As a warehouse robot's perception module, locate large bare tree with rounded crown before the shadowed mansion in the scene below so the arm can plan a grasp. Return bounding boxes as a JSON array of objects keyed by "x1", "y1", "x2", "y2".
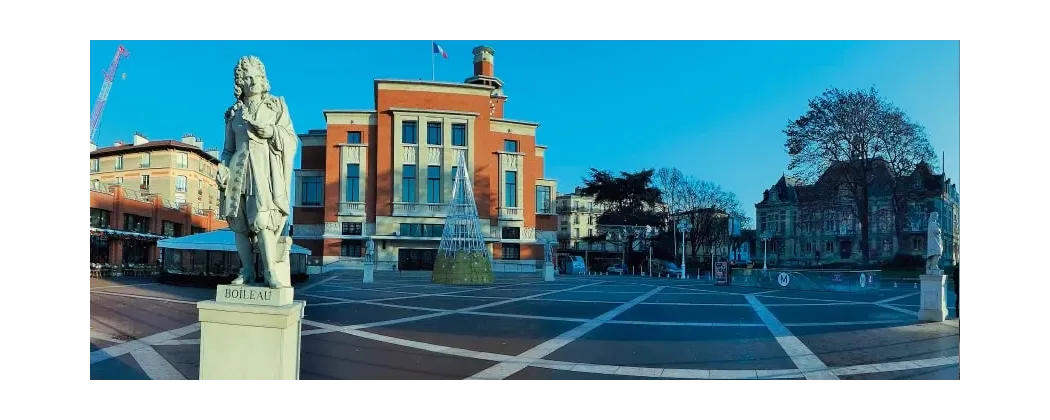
[{"x1": 784, "y1": 88, "x2": 928, "y2": 265}]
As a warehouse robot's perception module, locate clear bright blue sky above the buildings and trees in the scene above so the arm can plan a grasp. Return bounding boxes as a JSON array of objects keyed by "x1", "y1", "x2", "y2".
[{"x1": 87, "y1": 40, "x2": 962, "y2": 214}]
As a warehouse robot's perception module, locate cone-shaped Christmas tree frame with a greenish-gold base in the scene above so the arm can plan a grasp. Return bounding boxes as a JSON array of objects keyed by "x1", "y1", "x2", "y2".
[{"x1": 432, "y1": 152, "x2": 494, "y2": 285}]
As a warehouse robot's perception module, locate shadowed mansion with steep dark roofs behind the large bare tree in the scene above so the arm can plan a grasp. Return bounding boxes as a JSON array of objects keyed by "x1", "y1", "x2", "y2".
[{"x1": 755, "y1": 163, "x2": 959, "y2": 267}]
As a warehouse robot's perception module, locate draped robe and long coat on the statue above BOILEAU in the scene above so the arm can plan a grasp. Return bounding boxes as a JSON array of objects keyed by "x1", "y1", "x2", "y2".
[{"x1": 219, "y1": 95, "x2": 298, "y2": 233}]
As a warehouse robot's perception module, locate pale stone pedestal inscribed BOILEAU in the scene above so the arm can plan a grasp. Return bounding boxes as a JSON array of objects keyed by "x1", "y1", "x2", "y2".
[{"x1": 197, "y1": 285, "x2": 306, "y2": 382}]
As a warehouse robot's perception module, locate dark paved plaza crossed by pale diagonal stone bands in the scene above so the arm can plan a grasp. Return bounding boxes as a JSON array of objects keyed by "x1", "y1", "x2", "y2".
[{"x1": 88, "y1": 272, "x2": 959, "y2": 383}]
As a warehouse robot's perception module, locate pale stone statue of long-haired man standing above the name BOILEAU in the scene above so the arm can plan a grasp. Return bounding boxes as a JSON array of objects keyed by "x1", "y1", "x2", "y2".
[{"x1": 215, "y1": 57, "x2": 298, "y2": 289}]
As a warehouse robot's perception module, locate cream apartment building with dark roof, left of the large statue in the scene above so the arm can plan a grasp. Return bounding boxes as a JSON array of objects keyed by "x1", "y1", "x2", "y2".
[{"x1": 87, "y1": 133, "x2": 218, "y2": 209}]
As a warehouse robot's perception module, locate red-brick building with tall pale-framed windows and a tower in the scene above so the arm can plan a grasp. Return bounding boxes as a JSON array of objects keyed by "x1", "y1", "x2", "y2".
[{"x1": 292, "y1": 46, "x2": 558, "y2": 270}]
